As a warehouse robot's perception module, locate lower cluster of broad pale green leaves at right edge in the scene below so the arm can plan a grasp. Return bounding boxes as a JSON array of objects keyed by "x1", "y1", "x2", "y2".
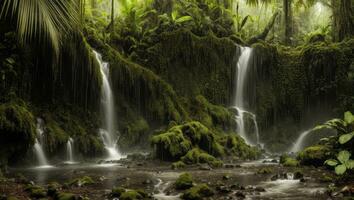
[{"x1": 325, "y1": 151, "x2": 354, "y2": 175}]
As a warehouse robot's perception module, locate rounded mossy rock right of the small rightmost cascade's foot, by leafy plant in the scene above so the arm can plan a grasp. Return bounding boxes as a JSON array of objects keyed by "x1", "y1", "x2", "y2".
[{"x1": 297, "y1": 145, "x2": 331, "y2": 167}]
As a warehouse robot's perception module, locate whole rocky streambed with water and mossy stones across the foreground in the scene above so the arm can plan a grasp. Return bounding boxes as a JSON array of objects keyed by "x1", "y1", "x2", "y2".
[{"x1": 0, "y1": 159, "x2": 350, "y2": 200}]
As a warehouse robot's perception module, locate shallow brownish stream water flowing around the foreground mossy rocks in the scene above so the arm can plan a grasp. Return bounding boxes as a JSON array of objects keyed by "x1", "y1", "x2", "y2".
[{"x1": 10, "y1": 159, "x2": 328, "y2": 200}]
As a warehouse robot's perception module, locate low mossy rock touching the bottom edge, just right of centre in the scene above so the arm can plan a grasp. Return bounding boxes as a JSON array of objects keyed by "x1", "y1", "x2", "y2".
[{"x1": 182, "y1": 184, "x2": 214, "y2": 200}]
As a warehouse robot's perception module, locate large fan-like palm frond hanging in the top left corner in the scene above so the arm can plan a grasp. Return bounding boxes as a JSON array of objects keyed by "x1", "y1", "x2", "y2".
[{"x1": 0, "y1": 0, "x2": 79, "y2": 54}]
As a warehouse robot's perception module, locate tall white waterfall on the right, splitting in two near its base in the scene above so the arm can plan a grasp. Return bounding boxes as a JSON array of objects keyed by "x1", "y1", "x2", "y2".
[{"x1": 233, "y1": 47, "x2": 259, "y2": 144}]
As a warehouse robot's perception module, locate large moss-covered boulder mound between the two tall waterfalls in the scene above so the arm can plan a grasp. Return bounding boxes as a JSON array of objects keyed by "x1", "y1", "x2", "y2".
[{"x1": 151, "y1": 121, "x2": 260, "y2": 164}]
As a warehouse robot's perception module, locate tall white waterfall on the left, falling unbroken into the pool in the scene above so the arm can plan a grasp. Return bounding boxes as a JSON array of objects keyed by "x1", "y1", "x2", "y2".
[{"x1": 93, "y1": 51, "x2": 122, "y2": 160}]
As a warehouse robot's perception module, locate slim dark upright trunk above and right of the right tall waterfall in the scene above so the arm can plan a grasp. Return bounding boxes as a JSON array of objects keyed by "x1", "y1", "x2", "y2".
[{"x1": 283, "y1": 0, "x2": 293, "y2": 45}]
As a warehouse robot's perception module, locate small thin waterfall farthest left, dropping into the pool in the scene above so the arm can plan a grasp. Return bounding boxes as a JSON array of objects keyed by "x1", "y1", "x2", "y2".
[{"x1": 33, "y1": 118, "x2": 49, "y2": 167}]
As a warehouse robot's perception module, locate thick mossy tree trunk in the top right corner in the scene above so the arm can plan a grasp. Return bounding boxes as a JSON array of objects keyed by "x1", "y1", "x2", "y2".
[{"x1": 331, "y1": 0, "x2": 354, "y2": 41}]
